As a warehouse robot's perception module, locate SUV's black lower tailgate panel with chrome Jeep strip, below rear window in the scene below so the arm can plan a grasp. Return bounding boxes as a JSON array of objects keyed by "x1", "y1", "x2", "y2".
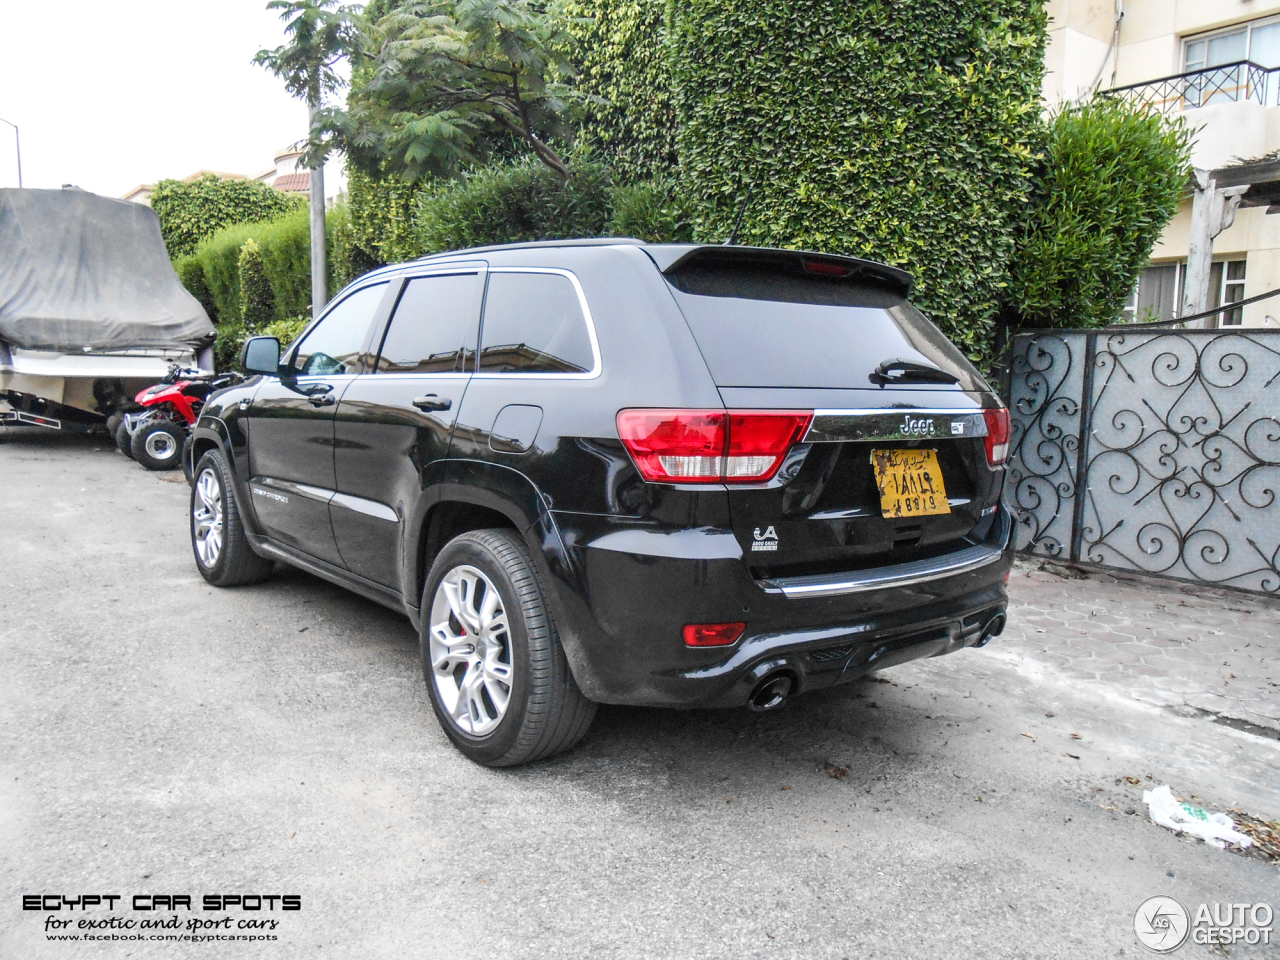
[{"x1": 721, "y1": 388, "x2": 1004, "y2": 577}]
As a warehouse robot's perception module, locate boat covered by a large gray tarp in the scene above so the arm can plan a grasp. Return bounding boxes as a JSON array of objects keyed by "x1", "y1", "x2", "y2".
[{"x1": 0, "y1": 187, "x2": 215, "y2": 426}]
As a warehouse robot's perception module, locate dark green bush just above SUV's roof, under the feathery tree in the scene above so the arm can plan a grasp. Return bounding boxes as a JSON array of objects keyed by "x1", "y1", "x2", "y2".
[{"x1": 416, "y1": 154, "x2": 611, "y2": 253}]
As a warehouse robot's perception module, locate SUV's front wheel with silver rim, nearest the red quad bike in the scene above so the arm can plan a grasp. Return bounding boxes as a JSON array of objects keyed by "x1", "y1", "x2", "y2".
[{"x1": 187, "y1": 449, "x2": 275, "y2": 586}]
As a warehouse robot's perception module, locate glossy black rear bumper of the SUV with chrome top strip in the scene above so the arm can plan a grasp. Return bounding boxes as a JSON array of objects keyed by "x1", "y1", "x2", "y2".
[{"x1": 545, "y1": 507, "x2": 1012, "y2": 707}]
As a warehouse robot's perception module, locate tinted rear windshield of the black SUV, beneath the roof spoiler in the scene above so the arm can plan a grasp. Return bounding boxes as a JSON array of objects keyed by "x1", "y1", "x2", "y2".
[{"x1": 667, "y1": 261, "x2": 984, "y2": 390}]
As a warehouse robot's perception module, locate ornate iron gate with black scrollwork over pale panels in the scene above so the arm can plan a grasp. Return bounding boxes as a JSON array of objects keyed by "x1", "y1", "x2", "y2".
[{"x1": 1006, "y1": 329, "x2": 1280, "y2": 594}]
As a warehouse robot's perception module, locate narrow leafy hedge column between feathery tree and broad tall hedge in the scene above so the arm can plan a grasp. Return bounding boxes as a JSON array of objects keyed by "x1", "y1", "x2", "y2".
[{"x1": 563, "y1": 0, "x2": 676, "y2": 183}]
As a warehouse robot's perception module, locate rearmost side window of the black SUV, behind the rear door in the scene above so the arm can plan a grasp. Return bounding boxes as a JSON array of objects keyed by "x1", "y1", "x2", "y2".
[{"x1": 480, "y1": 273, "x2": 595, "y2": 374}]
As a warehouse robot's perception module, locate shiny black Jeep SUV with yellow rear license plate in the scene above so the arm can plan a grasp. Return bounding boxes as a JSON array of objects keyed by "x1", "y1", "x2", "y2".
[{"x1": 187, "y1": 241, "x2": 1012, "y2": 765}]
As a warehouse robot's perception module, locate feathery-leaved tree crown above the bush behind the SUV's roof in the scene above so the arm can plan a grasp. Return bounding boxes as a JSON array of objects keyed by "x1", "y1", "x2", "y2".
[{"x1": 328, "y1": 0, "x2": 581, "y2": 180}]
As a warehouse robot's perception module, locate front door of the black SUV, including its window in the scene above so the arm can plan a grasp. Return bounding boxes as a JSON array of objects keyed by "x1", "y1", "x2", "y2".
[{"x1": 244, "y1": 282, "x2": 389, "y2": 564}]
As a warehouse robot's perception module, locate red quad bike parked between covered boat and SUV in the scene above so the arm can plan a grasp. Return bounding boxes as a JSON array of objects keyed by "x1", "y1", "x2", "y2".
[{"x1": 115, "y1": 365, "x2": 244, "y2": 480}]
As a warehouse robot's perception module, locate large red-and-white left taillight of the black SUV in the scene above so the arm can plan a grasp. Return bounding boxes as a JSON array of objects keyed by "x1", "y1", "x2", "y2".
[{"x1": 618, "y1": 410, "x2": 813, "y2": 484}]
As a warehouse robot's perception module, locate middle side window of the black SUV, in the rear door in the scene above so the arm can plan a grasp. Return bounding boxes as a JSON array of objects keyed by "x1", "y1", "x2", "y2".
[{"x1": 378, "y1": 274, "x2": 480, "y2": 374}]
